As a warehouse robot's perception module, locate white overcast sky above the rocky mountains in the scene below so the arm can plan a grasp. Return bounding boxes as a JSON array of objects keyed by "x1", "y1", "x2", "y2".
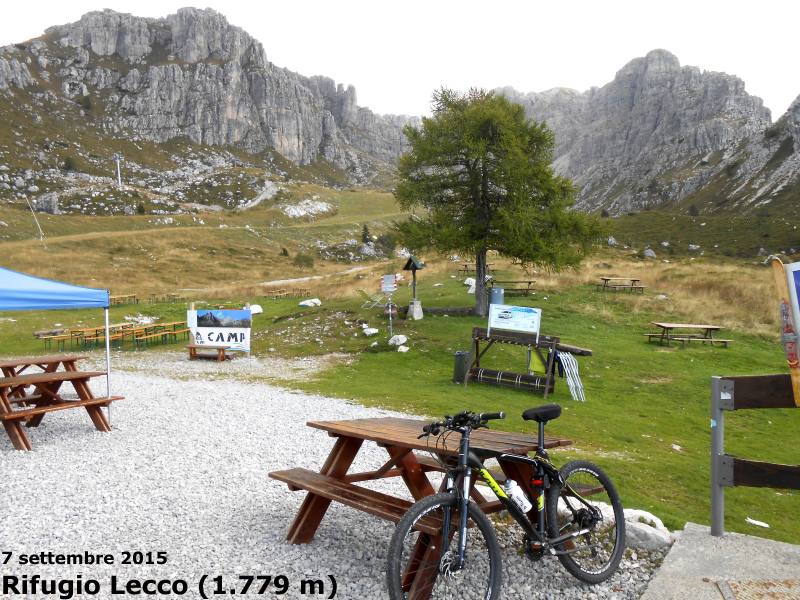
[{"x1": 0, "y1": 0, "x2": 800, "y2": 120}]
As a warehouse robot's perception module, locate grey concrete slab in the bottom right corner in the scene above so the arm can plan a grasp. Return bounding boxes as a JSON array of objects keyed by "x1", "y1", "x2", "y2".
[{"x1": 641, "y1": 523, "x2": 800, "y2": 600}]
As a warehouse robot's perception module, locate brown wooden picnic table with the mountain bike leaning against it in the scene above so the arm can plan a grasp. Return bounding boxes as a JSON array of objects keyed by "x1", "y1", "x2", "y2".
[{"x1": 269, "y1": 417, "x2": 572, "y2": 544}]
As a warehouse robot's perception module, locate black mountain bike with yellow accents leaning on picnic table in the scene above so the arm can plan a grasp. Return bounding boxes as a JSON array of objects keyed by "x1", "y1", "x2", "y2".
[{"x1": 387, "y1": 404, "x2": 625, "y2": 600}]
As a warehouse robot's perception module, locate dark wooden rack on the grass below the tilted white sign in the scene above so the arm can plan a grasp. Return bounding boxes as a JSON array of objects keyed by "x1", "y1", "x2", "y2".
[{"x1": 464, "y1": 327, "x2": 559, "y2": 398}]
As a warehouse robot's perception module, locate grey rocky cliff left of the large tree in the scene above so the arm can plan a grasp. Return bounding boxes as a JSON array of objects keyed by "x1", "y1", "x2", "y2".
[{"x1": 0, "y1": 8, "x2": 418, "y2": 180}]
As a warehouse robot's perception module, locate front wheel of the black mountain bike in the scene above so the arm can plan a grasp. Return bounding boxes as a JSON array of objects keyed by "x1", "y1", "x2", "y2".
[{"x1": 387, "y1": 494, "x2": 501, "y2": 600}]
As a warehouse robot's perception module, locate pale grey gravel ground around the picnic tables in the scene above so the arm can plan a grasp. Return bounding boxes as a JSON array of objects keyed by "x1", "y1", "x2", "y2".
[{"x1": 0, "y1": 353, "x2": 663, "y2": 600}]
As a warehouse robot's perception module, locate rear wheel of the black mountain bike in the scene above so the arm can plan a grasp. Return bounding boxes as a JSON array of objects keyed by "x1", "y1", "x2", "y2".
[{"x1": 547, "y1": 460, "x2": 625, "y2": 583}]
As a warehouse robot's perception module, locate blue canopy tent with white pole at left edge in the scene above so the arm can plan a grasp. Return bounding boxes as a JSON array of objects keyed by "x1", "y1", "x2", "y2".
[{"x1": 0, "y1": 267, "x2": 111, "y2": 412}]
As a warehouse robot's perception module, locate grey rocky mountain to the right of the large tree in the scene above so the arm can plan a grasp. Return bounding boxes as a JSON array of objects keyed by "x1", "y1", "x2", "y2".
[{"x1": 497, "y1": 50, "x2": 800, "y2": 215}]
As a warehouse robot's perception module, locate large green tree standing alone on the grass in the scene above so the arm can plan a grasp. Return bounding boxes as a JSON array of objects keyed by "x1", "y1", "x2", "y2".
[{"x1": 394, "y1": 88, "x2": 602, "y2": 316}]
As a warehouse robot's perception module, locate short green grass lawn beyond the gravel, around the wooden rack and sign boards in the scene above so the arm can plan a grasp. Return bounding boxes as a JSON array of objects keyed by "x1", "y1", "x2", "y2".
[{"x1": 2, "y1": 252, "x2": 800, "y2": 542}]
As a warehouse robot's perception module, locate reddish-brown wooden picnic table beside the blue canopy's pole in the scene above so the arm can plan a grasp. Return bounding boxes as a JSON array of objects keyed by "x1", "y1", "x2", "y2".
[{"x1": 0, "y1": 362, "x2": 123, "y2": 450}]
